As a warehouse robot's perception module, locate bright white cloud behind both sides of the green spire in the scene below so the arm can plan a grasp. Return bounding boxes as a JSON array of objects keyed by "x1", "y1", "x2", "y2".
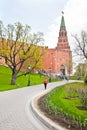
[{"x1": 45, "y1": 0, "x2": 87, "y2": 48}]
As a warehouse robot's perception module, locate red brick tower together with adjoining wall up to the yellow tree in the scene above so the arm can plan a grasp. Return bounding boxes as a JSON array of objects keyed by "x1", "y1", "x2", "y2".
[{"x1": 43, "y1": 12, "x2": 72, "y2": 75}]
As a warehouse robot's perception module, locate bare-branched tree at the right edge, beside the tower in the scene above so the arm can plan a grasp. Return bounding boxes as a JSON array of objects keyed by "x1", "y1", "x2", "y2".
[{"x1": 73, "y1": 31, "x2": 87, "y2": 60}]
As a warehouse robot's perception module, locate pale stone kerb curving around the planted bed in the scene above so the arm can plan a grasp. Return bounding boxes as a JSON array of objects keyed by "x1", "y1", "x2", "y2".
[{"x1": 30, "y1": 89, "x2": 67, "y2": 130}]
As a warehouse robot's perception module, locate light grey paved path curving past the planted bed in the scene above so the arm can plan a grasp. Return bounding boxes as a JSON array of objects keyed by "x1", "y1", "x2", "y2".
[{"x1": 0, "y1": 81, "x2": 72, "y2": 130}]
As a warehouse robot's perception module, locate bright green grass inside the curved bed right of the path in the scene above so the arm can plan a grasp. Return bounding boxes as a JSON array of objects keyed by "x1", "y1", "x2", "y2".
[{"x1": 42, "y1": 83, "x2": 87, "y2": 129}]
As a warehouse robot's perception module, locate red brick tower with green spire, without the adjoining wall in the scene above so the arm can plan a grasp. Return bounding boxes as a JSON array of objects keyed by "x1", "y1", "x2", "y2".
[{"x1": 57, "y1": 12, "x2": 72, "y2": 75}]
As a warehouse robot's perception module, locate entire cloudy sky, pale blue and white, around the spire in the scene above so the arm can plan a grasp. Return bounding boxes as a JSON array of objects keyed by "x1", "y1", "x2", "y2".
[{"x1": 0, "y1": 0, "x2": 87, "y2": 48}]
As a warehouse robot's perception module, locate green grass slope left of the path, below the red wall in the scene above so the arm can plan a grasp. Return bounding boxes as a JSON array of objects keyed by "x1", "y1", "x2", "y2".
[{"x1": 0, "y1": 66, "x2": 44, "y2": 91}]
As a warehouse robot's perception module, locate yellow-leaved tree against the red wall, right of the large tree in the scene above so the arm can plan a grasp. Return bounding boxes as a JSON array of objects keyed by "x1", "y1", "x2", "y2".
[{"x1": 22, "y1": 45, "x2": 46, "y2": 71}]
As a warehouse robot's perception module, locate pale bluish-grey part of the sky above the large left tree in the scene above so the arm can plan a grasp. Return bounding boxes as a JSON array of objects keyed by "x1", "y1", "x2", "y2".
[{"x1": 0, "y1": 0, "x2": 67, "y2": 32}]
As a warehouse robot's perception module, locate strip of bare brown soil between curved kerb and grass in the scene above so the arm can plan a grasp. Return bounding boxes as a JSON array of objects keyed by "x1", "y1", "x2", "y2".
[{"x1": 38, "y1": 95, "x2": 87, "y2": 130}]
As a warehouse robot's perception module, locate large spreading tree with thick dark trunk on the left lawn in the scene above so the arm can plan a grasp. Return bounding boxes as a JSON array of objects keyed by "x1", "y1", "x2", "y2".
[{"x1": 0, "y1": 21, "x2": 43, "y2": 85}]
